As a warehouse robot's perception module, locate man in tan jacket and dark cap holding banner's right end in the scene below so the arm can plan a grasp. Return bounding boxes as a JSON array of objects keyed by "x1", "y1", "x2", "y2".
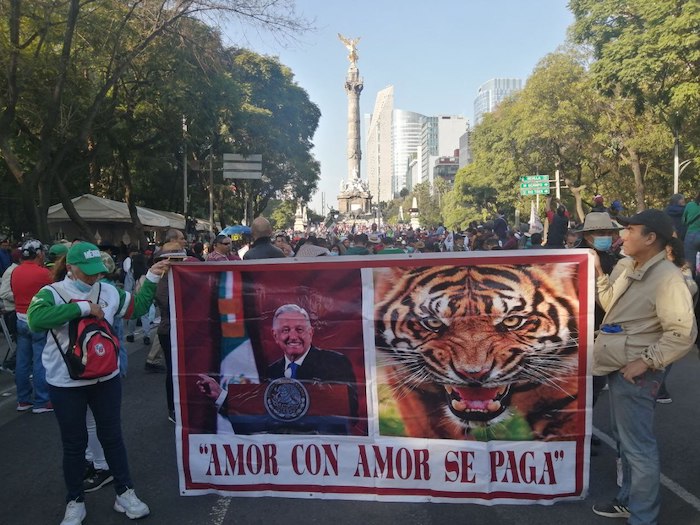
[{"x1": 593, "y1": 210, "x2": 697, "y2": 525}]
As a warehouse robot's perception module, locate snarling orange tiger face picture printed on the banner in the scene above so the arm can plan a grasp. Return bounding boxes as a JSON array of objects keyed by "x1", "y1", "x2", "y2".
[{"x1": 375, "y1": 264, "x2": 578, "y2": 439}]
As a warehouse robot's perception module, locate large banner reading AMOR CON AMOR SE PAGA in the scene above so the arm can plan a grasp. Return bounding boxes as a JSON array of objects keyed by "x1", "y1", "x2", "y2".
[{"x1": 170, "y1": 250, "x2": 593, "y2": 504}]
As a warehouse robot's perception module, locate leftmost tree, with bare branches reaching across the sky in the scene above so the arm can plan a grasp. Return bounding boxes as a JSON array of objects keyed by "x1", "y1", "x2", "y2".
[{"x1": 0, "y1": 0, "x2": 307, "y2": 240}]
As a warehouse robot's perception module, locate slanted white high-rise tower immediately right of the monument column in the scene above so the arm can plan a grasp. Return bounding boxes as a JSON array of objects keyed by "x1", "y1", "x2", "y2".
[{"x1": 365, "y1": 86, "x2": 395, "y2": 203}]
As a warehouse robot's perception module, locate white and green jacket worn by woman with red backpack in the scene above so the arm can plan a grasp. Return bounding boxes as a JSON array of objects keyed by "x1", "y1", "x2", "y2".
[{"x1": 27, "y1": 271, "x2": 160, "y2": 387}]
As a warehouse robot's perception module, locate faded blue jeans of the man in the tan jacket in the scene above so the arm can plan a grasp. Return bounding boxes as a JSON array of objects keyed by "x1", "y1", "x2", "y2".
[{"x1": 608, "y1": 370, "x2": 664, "y2": 525}]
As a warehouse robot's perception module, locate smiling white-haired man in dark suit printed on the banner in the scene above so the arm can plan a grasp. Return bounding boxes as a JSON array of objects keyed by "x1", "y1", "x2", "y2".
[{"x1": 197, "y1": 304, "x2": 358, "y2": 433}]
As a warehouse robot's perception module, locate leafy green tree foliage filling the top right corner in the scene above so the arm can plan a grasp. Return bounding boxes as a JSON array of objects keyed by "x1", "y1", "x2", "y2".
[{"x1": 569, "y1": 0, "x2": 700, "y2": 186}]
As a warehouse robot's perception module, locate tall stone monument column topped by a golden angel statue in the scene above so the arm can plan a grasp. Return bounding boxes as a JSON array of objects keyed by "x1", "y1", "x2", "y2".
[{"x1": 338, "y1": 33, "x2": 372, "y2": 218}]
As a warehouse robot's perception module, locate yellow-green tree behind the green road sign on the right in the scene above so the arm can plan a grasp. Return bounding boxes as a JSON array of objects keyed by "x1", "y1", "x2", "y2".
[{"x1": 443, "y1": 49, "x2": 670, "y2": 223}]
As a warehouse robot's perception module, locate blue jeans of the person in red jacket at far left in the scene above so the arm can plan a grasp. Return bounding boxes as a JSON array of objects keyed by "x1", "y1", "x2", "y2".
[{"x1": 15, "y1": 319, "x2": 49, "y2": 408}]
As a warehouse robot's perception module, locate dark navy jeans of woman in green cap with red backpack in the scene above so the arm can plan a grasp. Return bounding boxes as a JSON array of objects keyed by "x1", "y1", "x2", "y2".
[{"x1": 49, "y1": 376, "x2": 133, "y2": 502}]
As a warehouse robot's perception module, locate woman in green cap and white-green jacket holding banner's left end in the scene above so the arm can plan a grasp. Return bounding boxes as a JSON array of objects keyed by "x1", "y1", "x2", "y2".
[{"x1": 27, "y1": 242, "x2": 170, "y2": 525}]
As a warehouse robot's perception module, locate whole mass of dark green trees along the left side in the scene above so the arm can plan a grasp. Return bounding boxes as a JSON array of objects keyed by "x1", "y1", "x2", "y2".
[{"x1": 0, "y1": 0, "x2": 320, "y2": 240}]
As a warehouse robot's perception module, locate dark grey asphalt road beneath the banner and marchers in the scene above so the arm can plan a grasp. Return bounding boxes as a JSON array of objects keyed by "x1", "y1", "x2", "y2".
[{"x1": 0, "y1": 341, "x2": 700, "y2": 525}]
